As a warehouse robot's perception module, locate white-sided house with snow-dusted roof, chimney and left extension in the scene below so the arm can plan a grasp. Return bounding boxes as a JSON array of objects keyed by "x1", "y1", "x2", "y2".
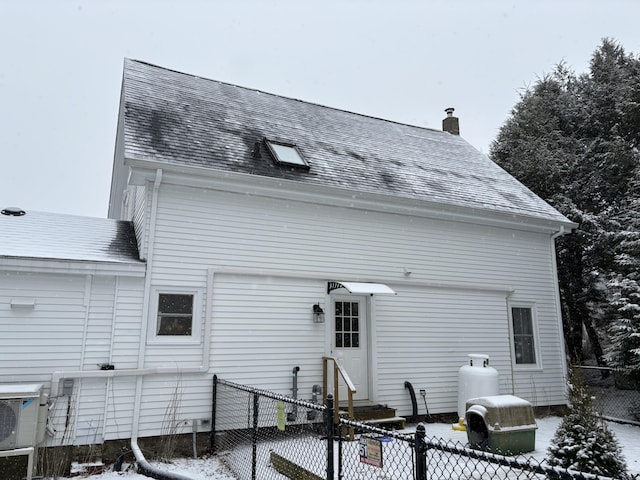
[{"x1": 0, "y1": 60, "x2": 575, "y2": 454}]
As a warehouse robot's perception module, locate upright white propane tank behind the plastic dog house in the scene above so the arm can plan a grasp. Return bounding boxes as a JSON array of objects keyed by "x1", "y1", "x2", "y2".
[{"x1": 458, "y1": 353, "x2": 499, "y2": 419}]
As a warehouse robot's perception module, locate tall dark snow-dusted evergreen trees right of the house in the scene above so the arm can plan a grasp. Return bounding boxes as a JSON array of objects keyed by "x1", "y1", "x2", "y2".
[{"x1": 491, "y1": 40, "x2": 640, "y2": 365}]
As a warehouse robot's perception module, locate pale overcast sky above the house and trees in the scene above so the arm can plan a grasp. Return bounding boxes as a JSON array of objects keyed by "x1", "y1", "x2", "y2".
[{"x1": 0, "y1": 0, "x2": 640, "y2": 217}]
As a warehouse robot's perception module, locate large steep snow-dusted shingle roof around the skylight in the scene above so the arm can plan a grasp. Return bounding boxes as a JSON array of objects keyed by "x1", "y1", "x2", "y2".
[{"x1": 123, "y1": 60, "x2": 568, "y2": 223}]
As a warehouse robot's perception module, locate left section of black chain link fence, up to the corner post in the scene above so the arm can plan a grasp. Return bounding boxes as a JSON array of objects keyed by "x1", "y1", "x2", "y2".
[{"x1": 211, "y1": 377, "x2": 329, "y2": 480}]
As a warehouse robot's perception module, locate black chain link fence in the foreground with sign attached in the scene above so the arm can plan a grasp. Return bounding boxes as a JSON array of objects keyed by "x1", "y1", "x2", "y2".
[{"x1": 211, "y1": 376, "x2": 632, "y2": 480}]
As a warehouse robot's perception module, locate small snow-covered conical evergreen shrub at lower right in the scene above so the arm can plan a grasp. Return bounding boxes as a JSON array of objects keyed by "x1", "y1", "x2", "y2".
[{"x1": 547, "y1": 371, "x2": 629, "y2": 479}]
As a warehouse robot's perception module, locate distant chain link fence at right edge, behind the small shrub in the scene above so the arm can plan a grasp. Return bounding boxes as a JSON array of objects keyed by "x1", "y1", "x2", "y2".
[{"x1": 577, "y1": 365, "x2": 640, "y2": 425}]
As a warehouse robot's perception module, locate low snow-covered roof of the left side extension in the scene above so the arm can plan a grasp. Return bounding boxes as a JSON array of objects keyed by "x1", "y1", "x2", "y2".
[{"x1": 0, "y1": 211, "x2": 140, "y2": 263}]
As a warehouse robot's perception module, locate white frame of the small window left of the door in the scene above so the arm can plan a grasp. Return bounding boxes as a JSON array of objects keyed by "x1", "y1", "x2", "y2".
[{"x1": 147, "y1": 287, "x2": 204, "y2": 345}]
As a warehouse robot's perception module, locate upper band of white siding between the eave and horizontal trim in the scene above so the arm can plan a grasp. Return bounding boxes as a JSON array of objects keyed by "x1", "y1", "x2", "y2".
[{"x1": 152, "y1": 186, "x2": 550, "y2": 289}]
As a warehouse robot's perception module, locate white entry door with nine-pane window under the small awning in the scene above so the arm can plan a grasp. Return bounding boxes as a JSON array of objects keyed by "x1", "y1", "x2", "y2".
[{"x1": 331, "y1": 296, "x2": 369, "y2": 400}]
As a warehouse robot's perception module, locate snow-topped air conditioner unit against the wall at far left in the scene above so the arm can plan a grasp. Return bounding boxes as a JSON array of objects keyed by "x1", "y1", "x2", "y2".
[{"x1": 0, "y1": 384, "x2": 46, "y2": 451}]
